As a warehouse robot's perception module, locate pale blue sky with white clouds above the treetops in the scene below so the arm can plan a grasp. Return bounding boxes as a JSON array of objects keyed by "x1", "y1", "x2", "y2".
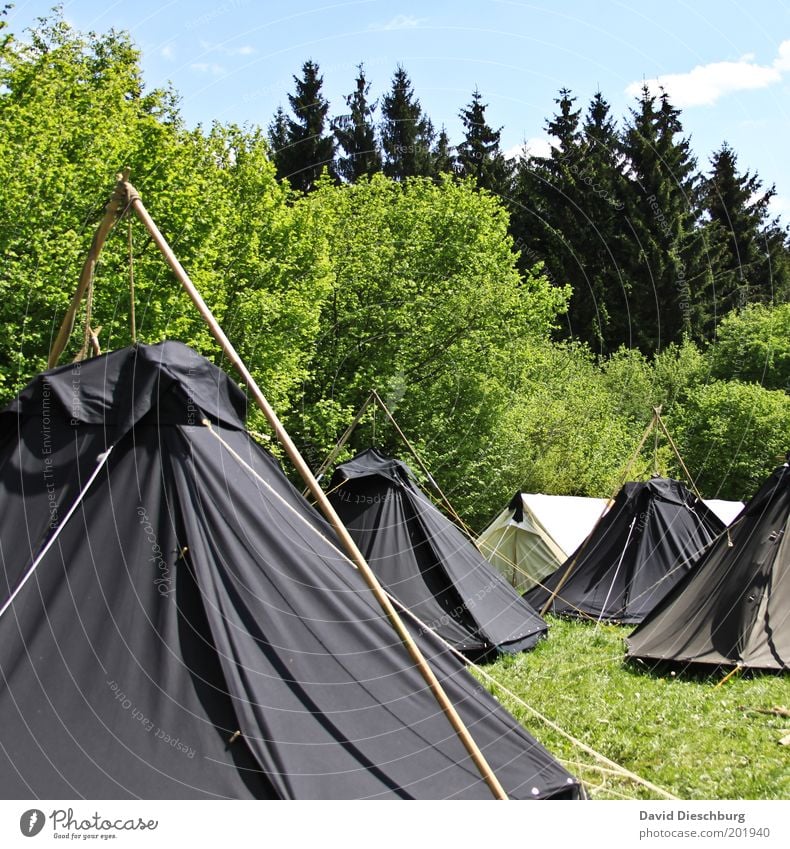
[{"x1": 10, "y1": 0, "x2": 790, "y2": 221}]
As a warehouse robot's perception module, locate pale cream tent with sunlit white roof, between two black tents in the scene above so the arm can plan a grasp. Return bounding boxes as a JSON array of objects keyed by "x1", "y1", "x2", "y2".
[{"x1": 477, "y1": 492, "x2": 607, "y2": 592}]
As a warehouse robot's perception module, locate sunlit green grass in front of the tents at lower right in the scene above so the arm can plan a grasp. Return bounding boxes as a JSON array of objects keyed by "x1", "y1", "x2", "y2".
[{"x1": 476, "y1": 617, "x2": 790, "y2": 799}]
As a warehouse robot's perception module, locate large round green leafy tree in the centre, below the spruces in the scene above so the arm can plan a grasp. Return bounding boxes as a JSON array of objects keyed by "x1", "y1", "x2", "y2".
[{"x1": 298, "y1": 175, "x2": 565, "y2": 510}]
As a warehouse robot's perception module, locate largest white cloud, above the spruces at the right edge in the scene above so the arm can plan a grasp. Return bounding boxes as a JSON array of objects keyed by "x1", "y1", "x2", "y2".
[{"x1": 625, "y1": 40, "x2": 790, "y2": 109}]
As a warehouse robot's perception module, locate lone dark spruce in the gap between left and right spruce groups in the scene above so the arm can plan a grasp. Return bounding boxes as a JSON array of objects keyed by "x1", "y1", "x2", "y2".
[{"x1": 457, "y1": 89, "x2": 510, "y2": 196}]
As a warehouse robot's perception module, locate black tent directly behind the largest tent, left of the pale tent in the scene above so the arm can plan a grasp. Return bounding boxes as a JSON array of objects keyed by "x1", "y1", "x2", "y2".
[{"x1": 329, "y1": 448, "x2": 548, "y2": 657}]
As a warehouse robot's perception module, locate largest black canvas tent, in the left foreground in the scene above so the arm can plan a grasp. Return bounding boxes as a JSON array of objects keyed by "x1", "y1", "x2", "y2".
[{"x1": 0, "y1": 342, "x2": 579, "y2": 799}]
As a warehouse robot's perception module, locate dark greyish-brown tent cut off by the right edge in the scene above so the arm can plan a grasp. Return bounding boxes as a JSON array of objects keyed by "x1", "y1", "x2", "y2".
[{"x1": 628, "y1": 464, "x2": 790, "y2": 670}]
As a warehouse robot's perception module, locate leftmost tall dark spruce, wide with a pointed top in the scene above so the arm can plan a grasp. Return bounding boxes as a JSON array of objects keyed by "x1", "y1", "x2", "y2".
[{"x1": 269, "y1": 59, "x2": 335, "y2": 192}]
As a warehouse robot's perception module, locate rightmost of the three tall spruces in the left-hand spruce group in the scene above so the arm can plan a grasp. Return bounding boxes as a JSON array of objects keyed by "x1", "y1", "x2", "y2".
[{"x1": 380, "y1": 66, "x2": 435, "y2": 180}]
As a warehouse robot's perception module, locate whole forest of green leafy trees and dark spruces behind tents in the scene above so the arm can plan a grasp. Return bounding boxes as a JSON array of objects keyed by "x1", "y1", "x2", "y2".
[{"x1": 0, "y1": 13, "x2": 790, "y2": 529}]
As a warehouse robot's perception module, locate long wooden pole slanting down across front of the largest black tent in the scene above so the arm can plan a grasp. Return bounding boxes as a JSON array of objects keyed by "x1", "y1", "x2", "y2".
[{"x1": 126, "y1": 183, "x2": 507, "y2": 799}]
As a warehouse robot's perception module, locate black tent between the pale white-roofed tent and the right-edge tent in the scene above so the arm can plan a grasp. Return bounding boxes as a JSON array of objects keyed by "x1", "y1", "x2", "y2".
[{"x1": 525, "y1": 477, "x2": 724, "y2": 624}]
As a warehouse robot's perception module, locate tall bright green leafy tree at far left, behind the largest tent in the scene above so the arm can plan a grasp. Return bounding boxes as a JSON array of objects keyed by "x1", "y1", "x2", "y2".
[{"x1": 0, "y1": 15, "x2": 329, "y2": 409}]
